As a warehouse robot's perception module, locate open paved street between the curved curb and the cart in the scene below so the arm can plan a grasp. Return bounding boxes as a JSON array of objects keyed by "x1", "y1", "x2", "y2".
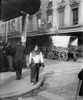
[{"x1": 0, "y1": 59, "x2": 82, "y2": 100}]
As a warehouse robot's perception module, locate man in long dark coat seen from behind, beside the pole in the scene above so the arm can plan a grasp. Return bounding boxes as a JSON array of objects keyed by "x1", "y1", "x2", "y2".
[{"x1": 13, "y1": 42, "x2": 25, "y2": 80}]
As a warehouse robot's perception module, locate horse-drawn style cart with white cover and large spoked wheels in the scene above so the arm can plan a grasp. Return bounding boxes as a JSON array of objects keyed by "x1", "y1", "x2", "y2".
[{"x1": 46, "y1": 36, "x2": 78, "y2": 61}]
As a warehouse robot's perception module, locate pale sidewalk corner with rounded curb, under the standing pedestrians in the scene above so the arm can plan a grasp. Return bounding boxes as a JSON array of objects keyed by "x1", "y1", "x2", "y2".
[{"x1": 0, "y1": 69, "x2": 43, "y2": 99}]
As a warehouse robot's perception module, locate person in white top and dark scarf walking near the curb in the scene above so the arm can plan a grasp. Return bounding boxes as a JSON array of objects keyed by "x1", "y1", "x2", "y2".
[{"x1": 29, "y1": 44, "x2": 44, "y2": 85}]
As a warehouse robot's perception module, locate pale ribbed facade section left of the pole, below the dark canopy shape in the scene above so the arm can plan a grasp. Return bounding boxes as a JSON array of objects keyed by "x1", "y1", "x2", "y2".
[{"x1": 0, "y1": 16, "x2": 22, "y2": 42}]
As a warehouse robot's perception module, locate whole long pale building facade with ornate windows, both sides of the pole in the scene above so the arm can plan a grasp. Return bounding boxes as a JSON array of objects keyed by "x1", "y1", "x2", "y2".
[{"x1": 0, "y1": 0, "x2": 83, "y2": 44}]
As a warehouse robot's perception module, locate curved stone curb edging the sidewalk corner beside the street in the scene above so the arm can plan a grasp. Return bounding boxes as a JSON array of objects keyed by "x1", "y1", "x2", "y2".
[{"x1": 0, "y1": 77, "x2": 44, "y2": 100}]
